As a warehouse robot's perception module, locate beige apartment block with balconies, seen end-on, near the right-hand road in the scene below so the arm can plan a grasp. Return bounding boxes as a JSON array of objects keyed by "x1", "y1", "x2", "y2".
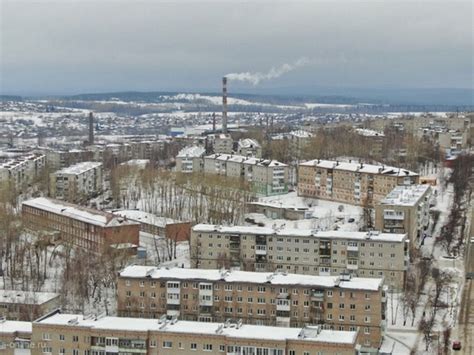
[{"x1": 375, "y1": 185, "x2": 431, "y2": 247}]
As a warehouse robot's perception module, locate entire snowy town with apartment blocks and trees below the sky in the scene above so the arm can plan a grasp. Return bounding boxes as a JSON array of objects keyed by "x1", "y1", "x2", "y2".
[{"x1": 0, "y1": 81, "x2": 474, "y2": 355}]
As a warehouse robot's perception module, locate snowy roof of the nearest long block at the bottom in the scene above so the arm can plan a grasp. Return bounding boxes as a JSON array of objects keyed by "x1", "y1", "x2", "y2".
[{"x1": 35, "y1": 313, "x2": 357, "y2": 344}]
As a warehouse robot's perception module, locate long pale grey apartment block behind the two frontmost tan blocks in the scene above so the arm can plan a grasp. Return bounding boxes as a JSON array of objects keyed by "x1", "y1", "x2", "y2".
[{"x1": 190, "y1": 224, "x2": 409, "y2": 288}]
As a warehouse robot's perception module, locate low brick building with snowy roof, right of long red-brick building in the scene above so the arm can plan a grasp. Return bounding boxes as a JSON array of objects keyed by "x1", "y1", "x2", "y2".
[{"x1": 112, "y1": 210, "x2": 191, "y2": 242}]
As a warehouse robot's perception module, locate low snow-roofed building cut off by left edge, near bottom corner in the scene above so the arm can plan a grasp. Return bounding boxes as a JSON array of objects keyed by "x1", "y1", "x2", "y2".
[{"x1": 0, "y1": 290, "x2": 59, "y2": 321}]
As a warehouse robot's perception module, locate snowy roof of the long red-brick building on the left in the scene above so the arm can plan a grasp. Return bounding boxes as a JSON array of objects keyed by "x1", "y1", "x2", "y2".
[{"x1": 23, "y1": 197, "x2": 138, "y2": 227}]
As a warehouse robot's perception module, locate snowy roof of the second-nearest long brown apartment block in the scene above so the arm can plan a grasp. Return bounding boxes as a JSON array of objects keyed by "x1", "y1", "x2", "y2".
[{"x1": 120, "y1": 265, "x2": 383, "y2": 291}]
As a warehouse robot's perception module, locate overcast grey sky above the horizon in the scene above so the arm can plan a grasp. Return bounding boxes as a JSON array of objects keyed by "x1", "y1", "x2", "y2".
[{"x1": 0, "y1": 0, "x2": 473, "y2": 94}]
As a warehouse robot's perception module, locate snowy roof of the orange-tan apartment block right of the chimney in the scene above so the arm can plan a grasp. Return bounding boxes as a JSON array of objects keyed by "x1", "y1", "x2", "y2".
[{"x1": 300, "y1": 159, "x2": 418, "y2": 176}]
